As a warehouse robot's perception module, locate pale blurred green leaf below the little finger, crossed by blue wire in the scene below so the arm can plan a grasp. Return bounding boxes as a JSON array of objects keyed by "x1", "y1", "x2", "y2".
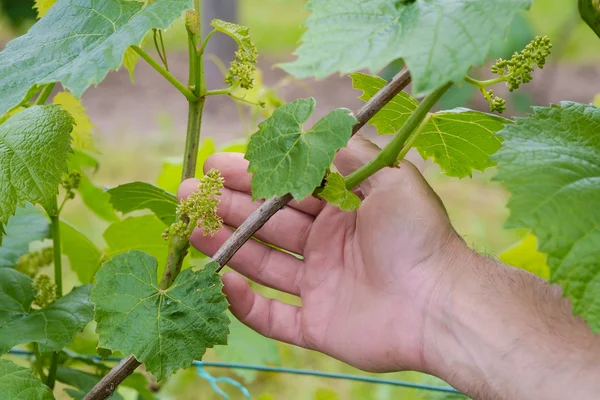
[{"x1": 215, "y1": 312, "x2": 281, "y2": 383}]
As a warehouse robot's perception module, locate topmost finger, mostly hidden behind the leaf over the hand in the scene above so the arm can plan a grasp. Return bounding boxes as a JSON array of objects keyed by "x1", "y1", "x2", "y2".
[{"x1": 204, "y1": 153, "x2": 326, "y2": 216}]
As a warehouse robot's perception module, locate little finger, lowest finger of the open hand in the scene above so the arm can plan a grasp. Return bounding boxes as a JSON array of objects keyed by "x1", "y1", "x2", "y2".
[{"x1": 223, "y1": 272, "x2": 307, "y2": 347}]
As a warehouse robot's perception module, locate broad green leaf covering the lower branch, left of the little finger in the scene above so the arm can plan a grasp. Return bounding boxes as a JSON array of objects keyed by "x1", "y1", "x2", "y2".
[{"x1": 92, "y1": 250, "x2": 229, "y2": 379}]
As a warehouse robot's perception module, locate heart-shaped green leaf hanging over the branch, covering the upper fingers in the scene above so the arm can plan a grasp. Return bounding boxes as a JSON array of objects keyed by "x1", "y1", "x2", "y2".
[{"x1": 246, "y1": 97, "x2": 356, "y2": 200}]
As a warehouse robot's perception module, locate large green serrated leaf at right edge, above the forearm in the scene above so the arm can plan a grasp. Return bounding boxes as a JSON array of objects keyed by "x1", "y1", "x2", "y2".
[{"x1": 495, "y1": 102, "x2": 600, "y2": 331}]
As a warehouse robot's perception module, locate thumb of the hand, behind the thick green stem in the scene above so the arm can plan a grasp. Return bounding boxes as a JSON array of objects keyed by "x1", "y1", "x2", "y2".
[{"x1": 334, "y1": 135, "x2": 420, "y2": 196}]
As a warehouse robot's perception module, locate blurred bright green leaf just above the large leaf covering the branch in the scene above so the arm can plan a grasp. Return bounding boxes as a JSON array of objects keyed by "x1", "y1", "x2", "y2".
[{"x1": 103, "y1": 214, "x2": 169, "y2": 272}]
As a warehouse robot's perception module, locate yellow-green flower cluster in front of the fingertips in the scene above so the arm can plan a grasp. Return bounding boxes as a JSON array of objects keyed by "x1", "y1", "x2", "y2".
[{"x1": 163, "y1": 169, "x2": 224, "y2": 240}]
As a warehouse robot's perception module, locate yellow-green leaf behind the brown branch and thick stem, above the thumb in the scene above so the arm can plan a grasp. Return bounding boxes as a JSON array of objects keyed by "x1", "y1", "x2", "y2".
[{"x1": 352, "y1": 73, "x2": 511, "y2": 178}]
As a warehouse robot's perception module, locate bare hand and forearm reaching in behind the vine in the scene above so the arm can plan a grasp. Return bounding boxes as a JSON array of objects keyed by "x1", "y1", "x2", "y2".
[{"x1": 179, "y1": 136, "x2": 600, "y2": 400}]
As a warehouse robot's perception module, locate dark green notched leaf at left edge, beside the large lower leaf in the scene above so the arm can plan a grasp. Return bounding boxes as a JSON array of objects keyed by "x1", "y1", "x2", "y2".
[{"x1": 0, "y1": 268, "x2": 93, "y2": 354}]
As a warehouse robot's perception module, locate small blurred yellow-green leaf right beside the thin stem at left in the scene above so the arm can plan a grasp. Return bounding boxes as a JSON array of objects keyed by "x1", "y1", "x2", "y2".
[{"x1": 60, "y1": 221, "x2": 102, "y2": 283}]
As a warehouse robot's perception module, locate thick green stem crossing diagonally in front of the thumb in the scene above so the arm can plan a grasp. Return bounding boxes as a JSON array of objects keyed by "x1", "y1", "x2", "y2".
[{"x1": 346, "y1": 82, "x2": 453, "y2": 190}]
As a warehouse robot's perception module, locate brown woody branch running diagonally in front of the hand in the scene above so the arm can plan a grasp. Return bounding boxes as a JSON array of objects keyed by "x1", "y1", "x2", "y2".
[{"x1": 84, "y1": 68, "x2": 411, "y2": 400}]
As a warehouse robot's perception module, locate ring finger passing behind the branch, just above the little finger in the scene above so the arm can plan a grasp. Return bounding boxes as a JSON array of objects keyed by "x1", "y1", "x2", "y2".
[{"x1": 190, "y1": 227, "x2": 304, "y2": 296}]
